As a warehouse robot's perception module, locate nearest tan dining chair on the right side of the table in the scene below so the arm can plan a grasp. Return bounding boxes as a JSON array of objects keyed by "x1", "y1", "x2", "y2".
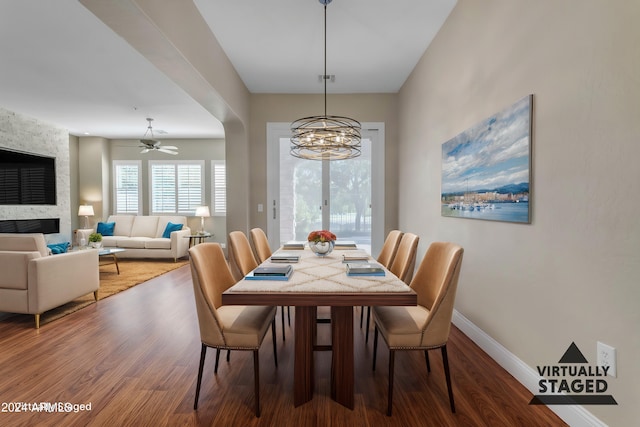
[{"x1": 373, "y1": 242, "x2": 464, "y2": 416}]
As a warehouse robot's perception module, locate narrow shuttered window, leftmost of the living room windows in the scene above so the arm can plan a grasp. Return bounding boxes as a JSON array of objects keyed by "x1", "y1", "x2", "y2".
[{"x1": 113, "y1": 160, "x2": 142, "y2": 215}]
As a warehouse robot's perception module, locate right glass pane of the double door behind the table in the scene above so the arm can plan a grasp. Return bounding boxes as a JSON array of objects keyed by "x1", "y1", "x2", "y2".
[{"x1": 327, "y1": 138, "x2": 371, "y2": 253}]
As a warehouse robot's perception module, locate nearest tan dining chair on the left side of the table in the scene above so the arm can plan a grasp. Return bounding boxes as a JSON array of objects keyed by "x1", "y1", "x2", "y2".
[{"x1": 189, "y1": 243, "x2": 278, "y2": 417}]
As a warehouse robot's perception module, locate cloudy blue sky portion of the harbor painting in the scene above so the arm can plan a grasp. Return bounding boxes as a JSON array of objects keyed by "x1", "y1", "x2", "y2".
[{"x1": 442, "y1": 96, "x2": 530, "y2": 193}]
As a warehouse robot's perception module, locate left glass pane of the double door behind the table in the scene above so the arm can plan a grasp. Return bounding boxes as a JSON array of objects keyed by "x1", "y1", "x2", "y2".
[{"x1": 278, "y1": 138, "x2": 322, "y2": 244}]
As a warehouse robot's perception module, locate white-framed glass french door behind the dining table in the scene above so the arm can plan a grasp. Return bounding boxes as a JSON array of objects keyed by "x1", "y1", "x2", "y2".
[{"x1": 267, "y1": 123, "x2": 384, "y2": 254}]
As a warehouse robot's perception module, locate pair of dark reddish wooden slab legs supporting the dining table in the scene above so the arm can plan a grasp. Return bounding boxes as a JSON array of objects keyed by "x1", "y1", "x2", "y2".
[{"x1": 293, "y1": 306, "x2": 354, "y2": 409}]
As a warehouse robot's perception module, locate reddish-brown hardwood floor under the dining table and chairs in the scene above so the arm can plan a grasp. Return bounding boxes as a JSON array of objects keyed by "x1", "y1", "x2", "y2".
[{"x1": 0, "y1": 266, "x2": 565, "y2": 427}]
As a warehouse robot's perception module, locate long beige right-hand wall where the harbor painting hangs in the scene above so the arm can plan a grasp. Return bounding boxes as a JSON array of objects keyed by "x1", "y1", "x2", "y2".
[{"x1": 399, "y1": 0, "x2": 640, "y2": 426}]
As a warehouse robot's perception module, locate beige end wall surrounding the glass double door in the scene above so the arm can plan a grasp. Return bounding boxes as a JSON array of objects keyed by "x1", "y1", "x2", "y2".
[{"x1": 249, "y1": 94, "x2": 398, "y2": 236}]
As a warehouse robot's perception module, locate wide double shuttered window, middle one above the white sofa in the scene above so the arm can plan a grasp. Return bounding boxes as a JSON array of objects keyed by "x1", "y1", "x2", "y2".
[{"x1": 149, "y1": 161, "x2": 204, "y2": 215}]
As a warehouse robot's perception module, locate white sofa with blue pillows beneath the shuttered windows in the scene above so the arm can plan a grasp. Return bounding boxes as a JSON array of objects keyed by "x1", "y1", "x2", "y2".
[{"x1": 77, "y1": 215, "x2": 191, "y2": 261}]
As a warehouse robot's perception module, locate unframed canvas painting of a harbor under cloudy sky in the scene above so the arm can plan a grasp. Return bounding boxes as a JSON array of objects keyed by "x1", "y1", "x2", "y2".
[{"x1": 441, "y1": 95, "x2": 533, "y2": 224}]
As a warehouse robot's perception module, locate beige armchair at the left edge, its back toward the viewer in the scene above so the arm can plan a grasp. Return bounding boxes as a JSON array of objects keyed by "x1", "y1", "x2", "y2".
[{"x1": 0, "y1": 233, "x2": 100, "y2": 328}]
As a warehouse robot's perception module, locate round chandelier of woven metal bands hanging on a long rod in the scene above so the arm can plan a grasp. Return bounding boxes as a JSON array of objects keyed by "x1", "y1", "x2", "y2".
[{"x1": 291, "y1": 0, "x2": 361, "y2": 160}]
